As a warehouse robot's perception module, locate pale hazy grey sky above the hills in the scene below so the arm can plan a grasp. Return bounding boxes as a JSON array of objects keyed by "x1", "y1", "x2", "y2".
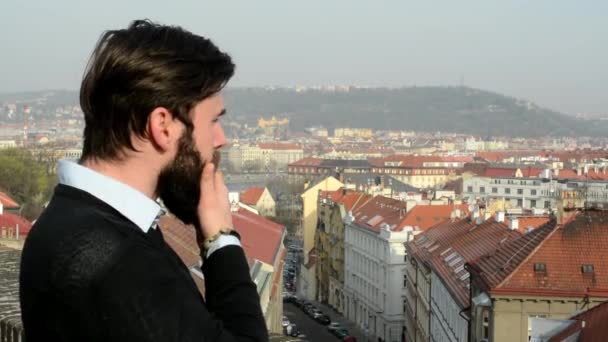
[{"x1": 0, "y1": 0, "x2": 608, "y2": 114}]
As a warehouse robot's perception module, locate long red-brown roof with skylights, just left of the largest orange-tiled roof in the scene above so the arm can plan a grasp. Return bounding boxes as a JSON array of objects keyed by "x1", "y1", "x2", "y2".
[{"x1": 408, "y1": 217, "x2": 521, "y2": 308}]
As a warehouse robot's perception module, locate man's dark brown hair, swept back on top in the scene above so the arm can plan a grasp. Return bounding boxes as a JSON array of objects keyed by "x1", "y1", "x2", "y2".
[{"x1": 80, "y1": 20, "x2": 235, "y2": 160}]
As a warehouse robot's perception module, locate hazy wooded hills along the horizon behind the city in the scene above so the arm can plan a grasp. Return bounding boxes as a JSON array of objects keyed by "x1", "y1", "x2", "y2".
[{"x1": 0, "y1": 87, "x2": 608, "y2": 137}]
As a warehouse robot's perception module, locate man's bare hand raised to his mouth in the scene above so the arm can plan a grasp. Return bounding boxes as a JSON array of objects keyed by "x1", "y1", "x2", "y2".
[{"x1": 197, "y1": 163, "x2": 233, "y2": 239}]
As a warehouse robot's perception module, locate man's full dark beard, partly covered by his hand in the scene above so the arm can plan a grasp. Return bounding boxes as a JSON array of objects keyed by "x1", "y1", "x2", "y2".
[{"x1": 157, "y1": 134, "x2": 220, "y2": 225}]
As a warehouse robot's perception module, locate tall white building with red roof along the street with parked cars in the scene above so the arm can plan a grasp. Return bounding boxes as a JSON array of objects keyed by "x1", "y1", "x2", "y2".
[{"x1": 344, "y1": 196, "x2": 412, "y2": 342}]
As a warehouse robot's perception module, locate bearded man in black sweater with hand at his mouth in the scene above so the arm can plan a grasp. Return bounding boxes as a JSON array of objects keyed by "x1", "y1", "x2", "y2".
[{"x1": 20, "y1": 21, "x2": 268, "y2": 342}]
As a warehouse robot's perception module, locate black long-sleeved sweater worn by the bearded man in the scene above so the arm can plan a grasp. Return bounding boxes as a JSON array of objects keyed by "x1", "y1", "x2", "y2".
[{"x1": 20, "y1": 185, "x2": 268, "y2": 342}]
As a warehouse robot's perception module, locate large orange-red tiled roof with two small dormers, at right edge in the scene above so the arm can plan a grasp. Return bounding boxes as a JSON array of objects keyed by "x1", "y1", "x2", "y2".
[{"x1": 471, "y1": 211, "x2": 608, "y2": 297}]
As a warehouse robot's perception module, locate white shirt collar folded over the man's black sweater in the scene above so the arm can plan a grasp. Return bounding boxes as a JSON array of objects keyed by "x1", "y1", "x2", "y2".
[{"x1": 58, "y1": 159, "x2": 162, "y2": 232}]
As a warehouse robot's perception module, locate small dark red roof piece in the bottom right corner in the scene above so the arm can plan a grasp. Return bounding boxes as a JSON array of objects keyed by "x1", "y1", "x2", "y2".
[{"x1": 549, "y1": 302, "x2": 608, "y2": 342}]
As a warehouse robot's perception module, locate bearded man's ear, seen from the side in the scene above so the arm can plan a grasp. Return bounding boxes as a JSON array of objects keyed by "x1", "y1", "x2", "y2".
[{"x1": 147, "y1": 107, "x2": 181, "y2": 151}]
